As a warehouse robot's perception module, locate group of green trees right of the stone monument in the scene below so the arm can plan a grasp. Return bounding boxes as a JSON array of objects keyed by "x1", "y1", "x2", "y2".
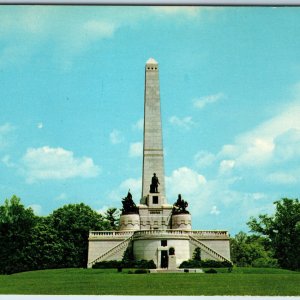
[{"x1": 230, "y1": 198, "x2": 300, "y2": 270}]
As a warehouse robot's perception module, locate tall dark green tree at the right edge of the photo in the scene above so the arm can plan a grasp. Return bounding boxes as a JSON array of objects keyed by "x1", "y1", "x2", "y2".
[{"x1": 248, "y1": 198, "x2": 300, "y2": 270}]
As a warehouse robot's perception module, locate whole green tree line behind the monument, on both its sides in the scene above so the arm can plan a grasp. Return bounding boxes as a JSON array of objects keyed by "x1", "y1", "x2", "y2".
[{"x1": 0, "y1": 196, "x2": 300, "y2": 274}]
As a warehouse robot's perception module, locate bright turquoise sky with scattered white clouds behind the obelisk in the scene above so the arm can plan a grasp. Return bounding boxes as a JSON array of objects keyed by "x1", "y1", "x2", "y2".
[{"x1": 0, "y1": 6, "x2": 300, "y2": 234}]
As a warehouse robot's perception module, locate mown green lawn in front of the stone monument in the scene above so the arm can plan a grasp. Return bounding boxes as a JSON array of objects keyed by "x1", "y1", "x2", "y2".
[{"x1": 0, "y1": 268, "x2": 300, "y2": 296}]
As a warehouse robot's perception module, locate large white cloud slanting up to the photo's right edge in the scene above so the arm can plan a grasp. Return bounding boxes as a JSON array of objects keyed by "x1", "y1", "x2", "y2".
[{"x1": 218, "y1": 97, "x2": 300, "y2": 168}]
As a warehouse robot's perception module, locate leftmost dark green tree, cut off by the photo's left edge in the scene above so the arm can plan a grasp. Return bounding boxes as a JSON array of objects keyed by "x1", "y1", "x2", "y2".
[{"x1": 0, "y1": 196, "x2": 38, "y2": 274}]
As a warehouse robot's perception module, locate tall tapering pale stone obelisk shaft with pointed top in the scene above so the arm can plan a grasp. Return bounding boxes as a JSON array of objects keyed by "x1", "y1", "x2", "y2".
[{"x1": 141, "y1": 58, "x2": 166, "y2": 205}]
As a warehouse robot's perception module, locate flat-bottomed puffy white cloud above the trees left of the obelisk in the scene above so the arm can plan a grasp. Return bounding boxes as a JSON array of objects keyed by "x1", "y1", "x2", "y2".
[{"x1": 22, "y1": 146, "x2": 100, "y2": 183}]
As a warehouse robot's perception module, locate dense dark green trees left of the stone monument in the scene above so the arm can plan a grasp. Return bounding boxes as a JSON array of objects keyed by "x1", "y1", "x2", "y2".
[{"x1": 0, "y1": 196, "x2": 112, "y2": 274}]
